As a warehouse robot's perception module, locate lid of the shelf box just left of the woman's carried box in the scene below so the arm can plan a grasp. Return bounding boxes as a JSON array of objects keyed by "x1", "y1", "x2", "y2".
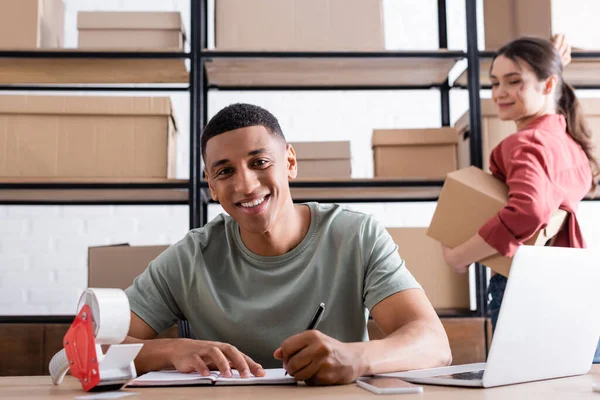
[{"x1": 372, "y1": 127, "x2": 457, "y2": 147}]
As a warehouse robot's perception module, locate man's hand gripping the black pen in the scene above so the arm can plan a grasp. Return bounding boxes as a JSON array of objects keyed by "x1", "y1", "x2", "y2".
[{"x1": 273, "y1": 330, "x2": 363, "y2": 385}]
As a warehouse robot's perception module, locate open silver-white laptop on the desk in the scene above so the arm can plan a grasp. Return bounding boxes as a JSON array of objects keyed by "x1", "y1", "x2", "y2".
[{"x1": 378, "y1": 246, "x2": 600, "y2": 388}]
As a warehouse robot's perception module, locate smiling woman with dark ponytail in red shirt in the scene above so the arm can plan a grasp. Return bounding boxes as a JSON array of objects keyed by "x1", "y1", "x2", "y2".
[{"x1": 444, "y1": 37, "x2": 600, "y2": 361}]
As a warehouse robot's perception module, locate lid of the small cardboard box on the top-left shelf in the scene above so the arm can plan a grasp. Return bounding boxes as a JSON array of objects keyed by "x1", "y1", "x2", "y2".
[{"x1": 77, "y1": 11, "x2": 183, "y2": 31}]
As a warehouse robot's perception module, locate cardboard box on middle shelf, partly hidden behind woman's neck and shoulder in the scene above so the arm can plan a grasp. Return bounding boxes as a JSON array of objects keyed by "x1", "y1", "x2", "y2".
[{"x1": 454, "y1": 99, "x2": 600, "y2": 172}]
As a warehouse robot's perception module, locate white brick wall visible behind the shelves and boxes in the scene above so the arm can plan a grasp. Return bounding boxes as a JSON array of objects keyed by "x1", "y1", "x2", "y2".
[{"x1": 0, "y1": 0, "x2": 600, "y2": 315}]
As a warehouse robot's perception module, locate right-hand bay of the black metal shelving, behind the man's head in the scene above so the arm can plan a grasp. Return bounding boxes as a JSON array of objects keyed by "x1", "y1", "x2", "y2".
[{"x1": 190, "y1": 0, "x2": 487, "y2": 317}]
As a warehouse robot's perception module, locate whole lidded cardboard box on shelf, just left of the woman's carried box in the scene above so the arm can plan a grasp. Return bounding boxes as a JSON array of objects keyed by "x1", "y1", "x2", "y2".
[{"x1": 372, "y1": 127, "x2": 457, "y2": 179}]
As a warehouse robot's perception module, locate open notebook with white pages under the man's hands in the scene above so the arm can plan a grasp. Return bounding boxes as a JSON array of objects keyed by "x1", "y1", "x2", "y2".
[{"x1": 127, "y1": 368, "x2": 296, "y2": 387}]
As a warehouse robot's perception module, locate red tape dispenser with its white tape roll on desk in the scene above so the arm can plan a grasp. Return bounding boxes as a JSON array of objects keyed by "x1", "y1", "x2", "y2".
[{"x1": 49, "y1": 289, "x2": 143, "y2": 392}]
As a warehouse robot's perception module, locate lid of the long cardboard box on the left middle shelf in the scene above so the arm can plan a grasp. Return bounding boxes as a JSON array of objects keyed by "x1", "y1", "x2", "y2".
[{"x1": 0, "y1": 95, "x2": 172, "y2": 115}]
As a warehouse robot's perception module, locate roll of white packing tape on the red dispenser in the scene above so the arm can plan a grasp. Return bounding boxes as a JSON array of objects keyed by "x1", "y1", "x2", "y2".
[{"x1": 77, "y1": 289, "x2": 131, "y2": 344}]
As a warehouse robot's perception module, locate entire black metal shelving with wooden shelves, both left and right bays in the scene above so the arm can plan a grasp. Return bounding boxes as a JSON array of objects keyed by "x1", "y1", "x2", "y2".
[{"x1": 0, "y1": 0, "x2": 496, "y2": 333}]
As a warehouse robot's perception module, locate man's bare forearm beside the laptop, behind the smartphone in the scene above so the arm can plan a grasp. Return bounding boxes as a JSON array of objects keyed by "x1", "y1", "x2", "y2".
[{"x1": 350, "y1": 321, "x2": 452, "y2": 375}]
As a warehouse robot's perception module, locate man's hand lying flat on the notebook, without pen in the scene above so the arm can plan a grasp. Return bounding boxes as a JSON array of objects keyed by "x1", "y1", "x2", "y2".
[{"x1": 169, "y1": 339, "x2": 265, "y2": 378}]
